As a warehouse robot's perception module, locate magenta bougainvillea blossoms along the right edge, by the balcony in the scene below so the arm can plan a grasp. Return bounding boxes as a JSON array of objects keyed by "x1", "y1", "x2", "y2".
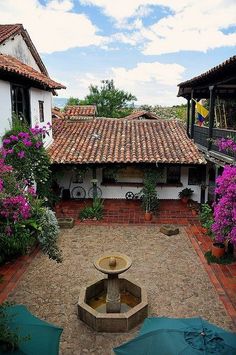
[{"x1": 212, "y1": 138, "x2": 236, "y2": 248}]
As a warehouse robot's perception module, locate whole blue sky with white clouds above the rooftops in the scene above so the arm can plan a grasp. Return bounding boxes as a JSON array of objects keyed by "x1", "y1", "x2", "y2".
[{"x1": 0, "y1": 0, "x2": 236, "y2": 106}]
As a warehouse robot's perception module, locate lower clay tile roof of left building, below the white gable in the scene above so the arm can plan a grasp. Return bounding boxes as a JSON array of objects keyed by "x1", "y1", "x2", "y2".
[{"x1": 0, "y1": 54, "x2": 66, "y2": 89}]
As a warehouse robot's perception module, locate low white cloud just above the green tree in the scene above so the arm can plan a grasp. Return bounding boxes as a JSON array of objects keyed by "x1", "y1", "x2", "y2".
[{"x1": 58, "y1": 62, "x2": 185, "y2": 105}]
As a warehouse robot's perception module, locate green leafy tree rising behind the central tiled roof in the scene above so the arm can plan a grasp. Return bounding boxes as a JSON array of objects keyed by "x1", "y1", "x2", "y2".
[{"x1": 84, "y1": 80, "x2": 137, "y2": 117}]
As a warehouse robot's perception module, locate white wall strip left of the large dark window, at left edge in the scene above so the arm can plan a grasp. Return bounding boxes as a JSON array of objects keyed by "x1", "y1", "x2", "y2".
[{"x1": 0, "y1": 80, "x2": 11, "y2": 140}]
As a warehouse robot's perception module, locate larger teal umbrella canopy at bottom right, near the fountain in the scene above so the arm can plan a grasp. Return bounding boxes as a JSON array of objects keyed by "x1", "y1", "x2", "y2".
[{"x1": 113, "y1": 317, "x2": 236, "y2": 355}]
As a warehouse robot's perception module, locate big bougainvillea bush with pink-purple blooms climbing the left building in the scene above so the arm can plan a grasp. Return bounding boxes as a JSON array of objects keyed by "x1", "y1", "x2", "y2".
[{"x1": 0, "y1": 122, "x2": 61, "y2": 263}]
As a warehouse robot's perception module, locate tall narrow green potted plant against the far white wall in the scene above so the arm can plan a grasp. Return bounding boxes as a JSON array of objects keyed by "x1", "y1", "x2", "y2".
[{"x1": 139, "y1": 169, "x2": 159, "y2": 212}]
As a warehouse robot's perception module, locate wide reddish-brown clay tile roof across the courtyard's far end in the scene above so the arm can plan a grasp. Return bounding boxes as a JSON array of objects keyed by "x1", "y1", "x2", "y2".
[{"x1": 48, "y1": 118, "x2": 205, "y2": 164}]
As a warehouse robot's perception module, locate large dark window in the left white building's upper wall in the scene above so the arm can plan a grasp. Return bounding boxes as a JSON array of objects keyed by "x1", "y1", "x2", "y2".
[{"x1": 11, "y1": 85, "x2": 30, "y2": 124}]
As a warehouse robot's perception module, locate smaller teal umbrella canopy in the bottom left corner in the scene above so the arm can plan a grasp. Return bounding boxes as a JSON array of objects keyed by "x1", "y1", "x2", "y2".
[{"x1": 4, "y1": 305, "x2": 63, "y2": 355}]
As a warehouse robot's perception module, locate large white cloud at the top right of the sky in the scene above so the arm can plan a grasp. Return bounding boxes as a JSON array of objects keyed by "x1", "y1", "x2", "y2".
[{"x1": 81, "y1": 0, "x2": 236, "y2": 55}]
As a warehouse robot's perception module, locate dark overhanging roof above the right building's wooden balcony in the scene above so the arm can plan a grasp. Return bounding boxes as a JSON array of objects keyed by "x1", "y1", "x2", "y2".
[{"x1": 178, "y1": 55, "x2": 236, "y2": 87}]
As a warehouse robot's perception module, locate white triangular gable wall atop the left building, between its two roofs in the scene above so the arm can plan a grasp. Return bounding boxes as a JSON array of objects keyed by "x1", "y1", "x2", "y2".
[{"x1": 0, "y1": 34, "x2": 40, "y2": 72}]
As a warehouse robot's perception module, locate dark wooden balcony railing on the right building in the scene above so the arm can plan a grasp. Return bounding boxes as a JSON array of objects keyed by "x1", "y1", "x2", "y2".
[{"x1": 194, "y1": 125, "x2": 236, "y2": 158}]
